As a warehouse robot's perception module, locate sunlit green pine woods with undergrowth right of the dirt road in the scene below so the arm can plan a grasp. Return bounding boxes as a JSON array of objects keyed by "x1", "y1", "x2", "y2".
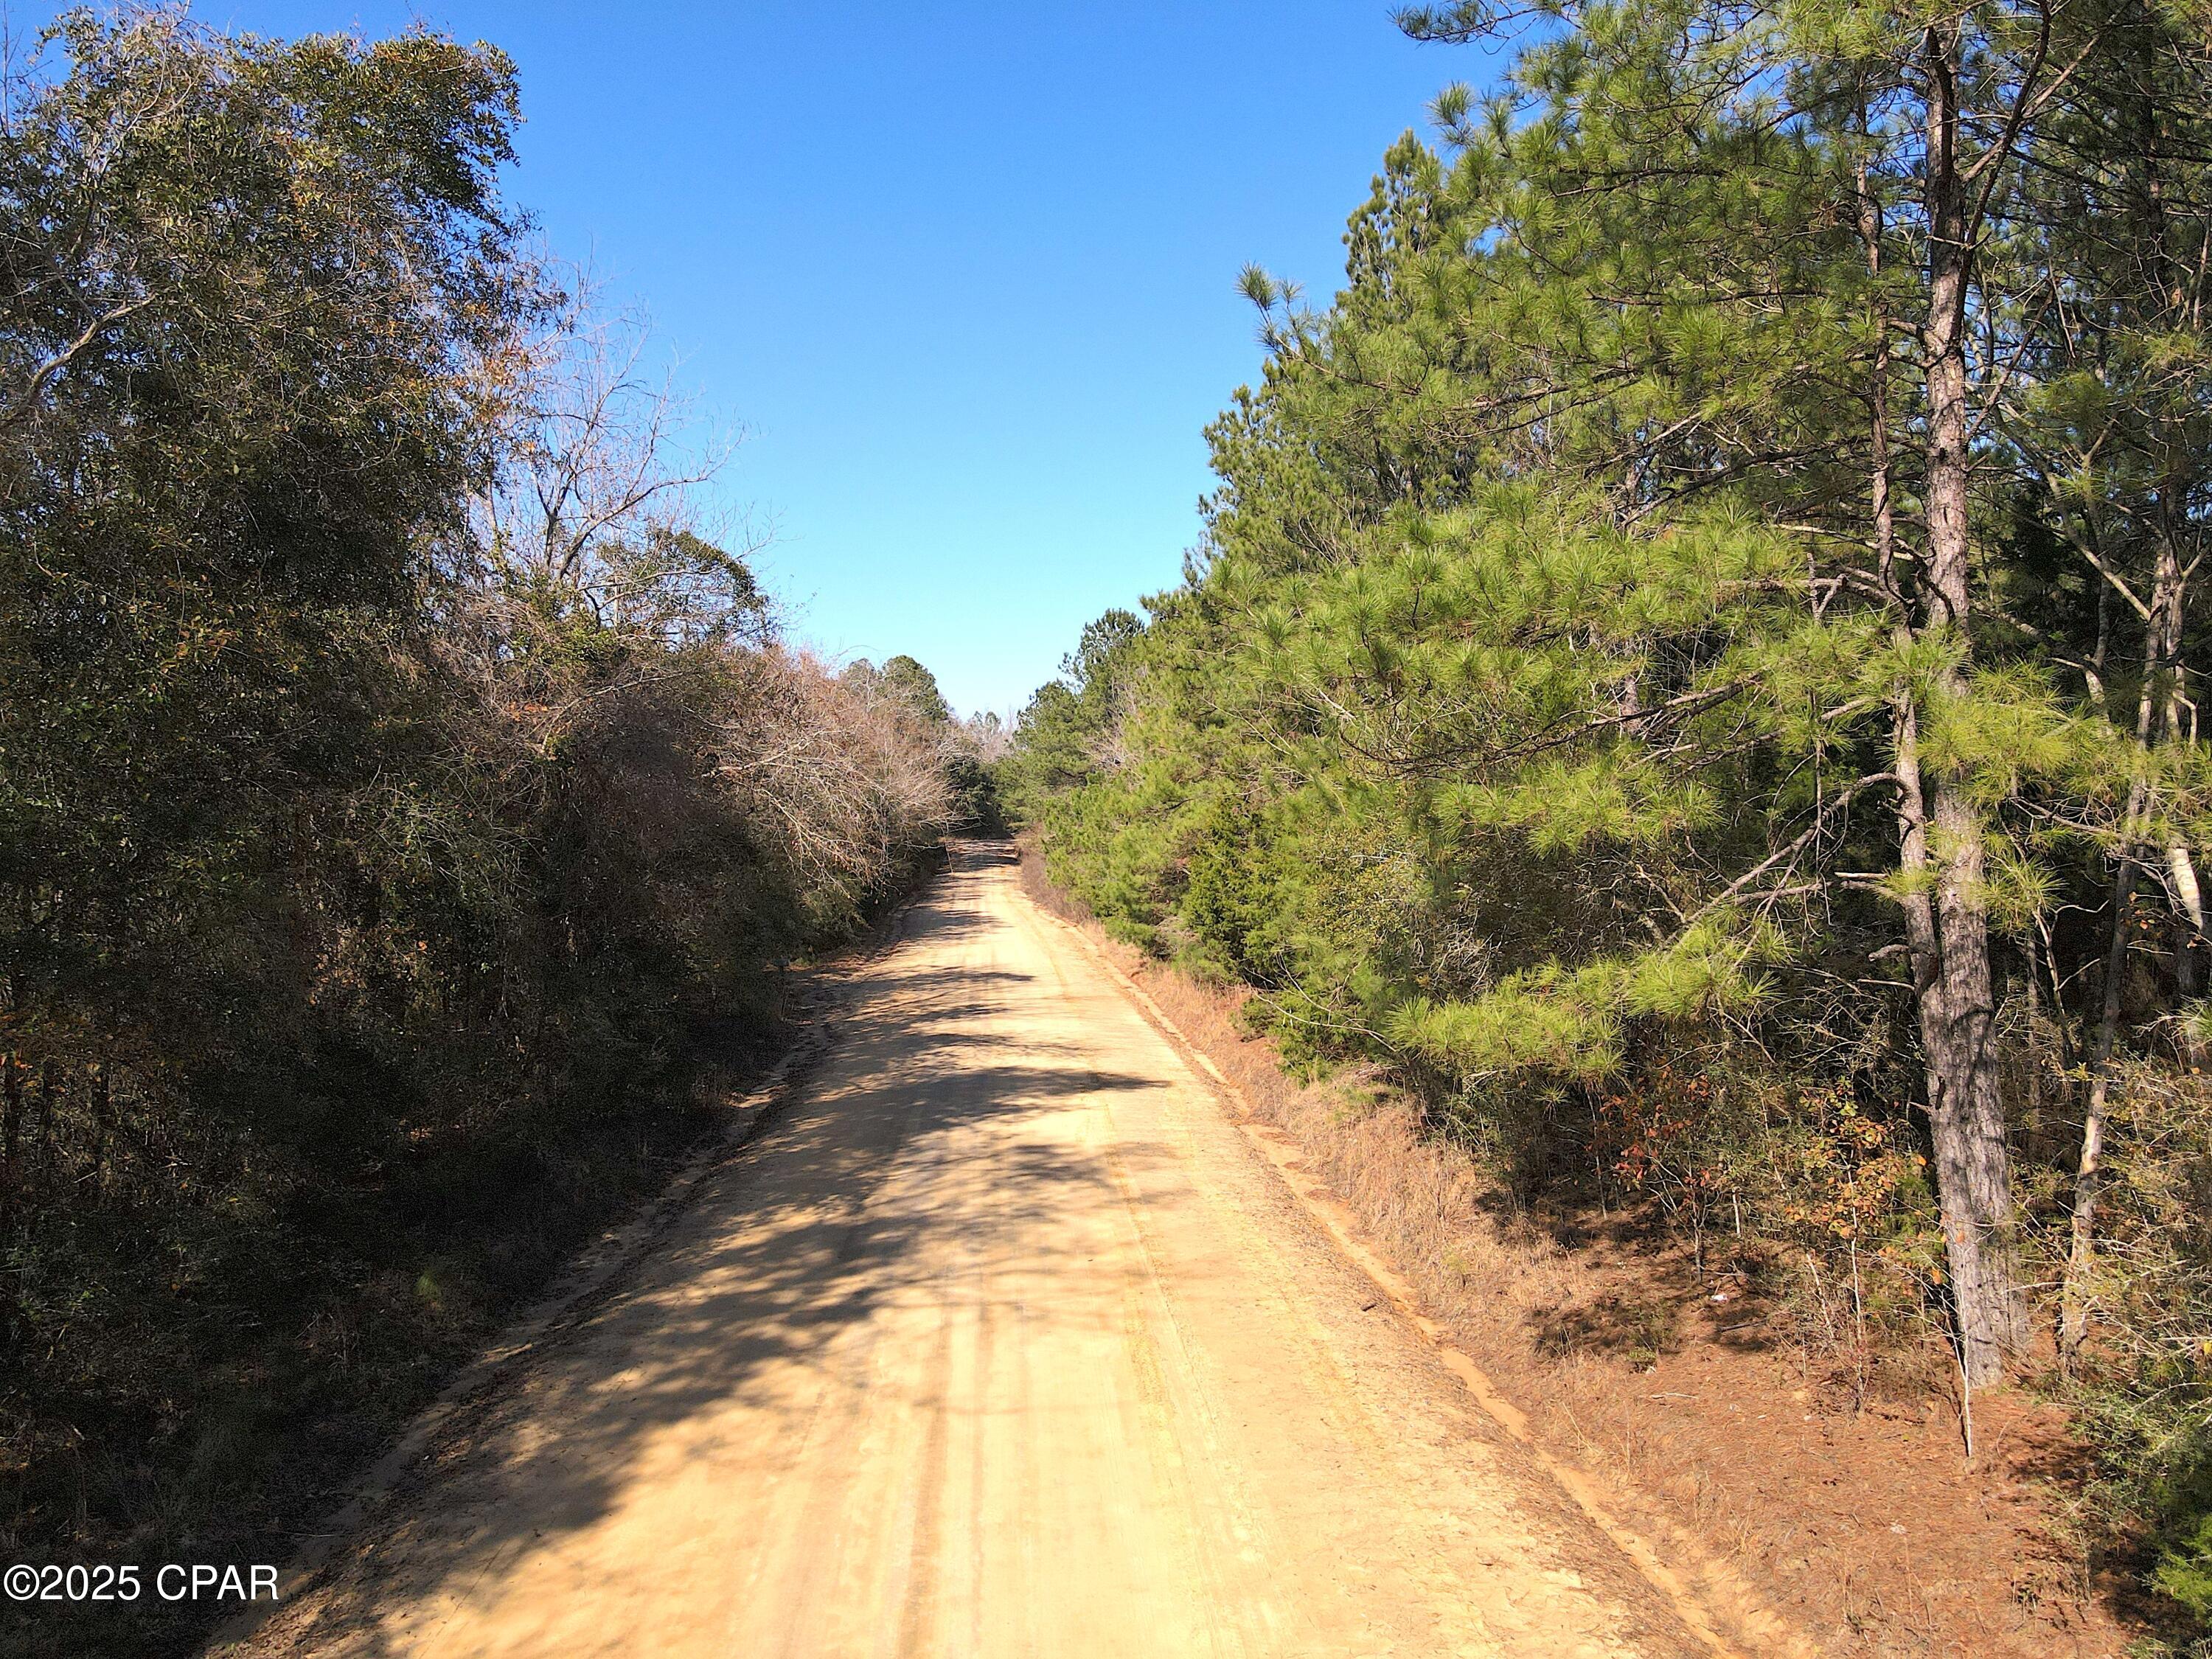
[{"x1": 1002, "y1": 0, "x2": 2212, "y2": 1639}]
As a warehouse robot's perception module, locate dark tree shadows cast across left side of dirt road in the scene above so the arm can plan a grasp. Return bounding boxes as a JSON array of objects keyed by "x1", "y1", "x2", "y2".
[{"x1": 263, "y1": 863, "x2": 1172, "y2": 1655}]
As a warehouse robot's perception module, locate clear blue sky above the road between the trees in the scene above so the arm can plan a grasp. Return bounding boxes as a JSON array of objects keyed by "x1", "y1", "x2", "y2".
[{"x1": 21, "y1": 0, "x2": 1486, "y2": 710}]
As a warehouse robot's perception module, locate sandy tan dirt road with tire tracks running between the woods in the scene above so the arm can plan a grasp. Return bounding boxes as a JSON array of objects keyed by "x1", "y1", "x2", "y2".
[{"x1": 233, "y1": 847, "x2": 1703, "y2": 1659}]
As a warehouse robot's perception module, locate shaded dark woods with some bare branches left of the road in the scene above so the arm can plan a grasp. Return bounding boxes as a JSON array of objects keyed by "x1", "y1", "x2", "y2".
[{"x1": 0, "y1": 11, "x2": 969, "y2": 1650}]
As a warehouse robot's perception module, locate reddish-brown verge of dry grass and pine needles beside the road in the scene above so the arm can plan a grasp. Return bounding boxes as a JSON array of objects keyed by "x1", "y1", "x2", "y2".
[{"x1": 1022, "y1": 852, "x2": 2130, "y2": 1659}]
